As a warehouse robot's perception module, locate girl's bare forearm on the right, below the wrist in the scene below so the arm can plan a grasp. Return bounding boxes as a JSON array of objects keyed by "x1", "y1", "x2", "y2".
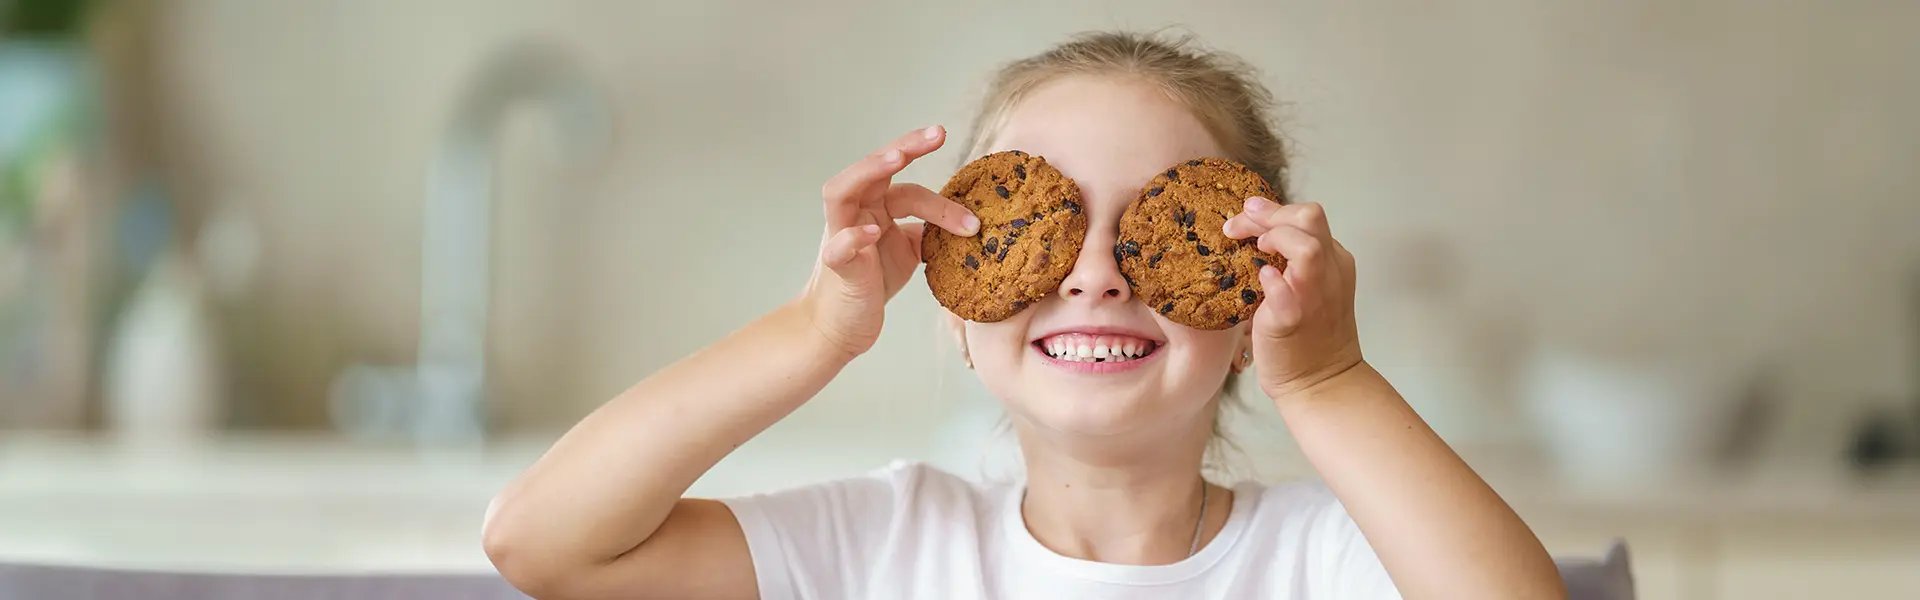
[{"x1": 1275, "y1": 362, "x2": 1565, "y2": 598}]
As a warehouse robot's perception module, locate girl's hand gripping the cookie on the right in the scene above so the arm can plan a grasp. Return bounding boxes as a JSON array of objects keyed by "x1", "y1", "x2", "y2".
[{"x1": 1223, "y1": 198, "x2": 1361, "y2": 400}]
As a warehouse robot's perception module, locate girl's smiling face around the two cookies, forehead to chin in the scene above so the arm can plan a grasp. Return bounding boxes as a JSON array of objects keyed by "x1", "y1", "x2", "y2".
[{"x1": 964, "y1": 77, "x2": 1248, "y2": 438}]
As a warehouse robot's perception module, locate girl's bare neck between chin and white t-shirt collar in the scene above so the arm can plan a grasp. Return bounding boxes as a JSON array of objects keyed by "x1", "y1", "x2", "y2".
[{"x1": 1020, "y1": 417, "x2": 1233, "y2": 565}]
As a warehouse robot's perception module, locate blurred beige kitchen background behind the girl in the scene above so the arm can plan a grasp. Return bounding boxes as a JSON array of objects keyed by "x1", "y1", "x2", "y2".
[{"x1": 0, "y1": 0, "x2": 1920, "y2": 598}]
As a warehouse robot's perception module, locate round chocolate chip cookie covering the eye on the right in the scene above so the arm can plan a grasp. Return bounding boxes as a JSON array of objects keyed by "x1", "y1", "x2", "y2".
[{"x1": 1114, "y1": 158, "x2": 1286, "y2": 329}]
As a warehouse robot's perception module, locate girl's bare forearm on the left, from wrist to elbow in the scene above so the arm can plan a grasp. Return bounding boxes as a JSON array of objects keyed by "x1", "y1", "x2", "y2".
[{"x1": 486, "y1": 306, "x2": 851, "y2": 563}]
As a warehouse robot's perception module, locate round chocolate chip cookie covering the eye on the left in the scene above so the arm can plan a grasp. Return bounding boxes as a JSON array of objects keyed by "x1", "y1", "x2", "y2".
[{"x1": 920, "y1": 150, "x2": 1087, "y2": 323}]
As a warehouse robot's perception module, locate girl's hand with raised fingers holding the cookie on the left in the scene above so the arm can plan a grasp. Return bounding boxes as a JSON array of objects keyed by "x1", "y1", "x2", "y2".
[{"x1": 801, "y1": 125, "x2": 979, "y2": 358}]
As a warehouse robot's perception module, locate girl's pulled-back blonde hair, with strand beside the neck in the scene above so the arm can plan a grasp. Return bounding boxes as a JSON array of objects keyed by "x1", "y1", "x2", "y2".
[{"x1": 962, "y1": 31, "x2": 1290, "y2": 477}]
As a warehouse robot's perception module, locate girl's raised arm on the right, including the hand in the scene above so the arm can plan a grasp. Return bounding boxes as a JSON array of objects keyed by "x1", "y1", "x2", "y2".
[{"x1": 1227, "y1": 198, "x2": 1567, "y2": 598}]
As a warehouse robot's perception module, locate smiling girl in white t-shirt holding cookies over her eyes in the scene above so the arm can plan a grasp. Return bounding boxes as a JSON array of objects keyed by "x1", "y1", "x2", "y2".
[{"x1": 484, "y1": 33, "x2": 1565, "y2": 598}]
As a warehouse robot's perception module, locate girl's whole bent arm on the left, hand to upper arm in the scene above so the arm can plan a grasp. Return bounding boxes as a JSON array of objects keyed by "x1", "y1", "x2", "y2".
[{"x1": 482, "y1": 127, "x2": 979, "y2": 598}]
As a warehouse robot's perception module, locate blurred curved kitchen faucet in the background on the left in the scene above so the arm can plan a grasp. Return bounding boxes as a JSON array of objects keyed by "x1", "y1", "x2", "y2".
[{"x1": 332, "y1": 44, "x2": 612, "y2": 442}]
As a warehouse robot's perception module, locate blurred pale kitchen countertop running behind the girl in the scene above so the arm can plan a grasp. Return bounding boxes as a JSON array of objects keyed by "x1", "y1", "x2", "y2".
[{"x1": 0, "y1": 429, "x2": 1920, "y2": 573}]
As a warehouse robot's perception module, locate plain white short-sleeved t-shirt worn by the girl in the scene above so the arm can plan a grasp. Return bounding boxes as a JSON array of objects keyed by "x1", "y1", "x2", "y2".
[{"x1": 724, "y1": 462, "x2": 1400, "y2": 600}]
